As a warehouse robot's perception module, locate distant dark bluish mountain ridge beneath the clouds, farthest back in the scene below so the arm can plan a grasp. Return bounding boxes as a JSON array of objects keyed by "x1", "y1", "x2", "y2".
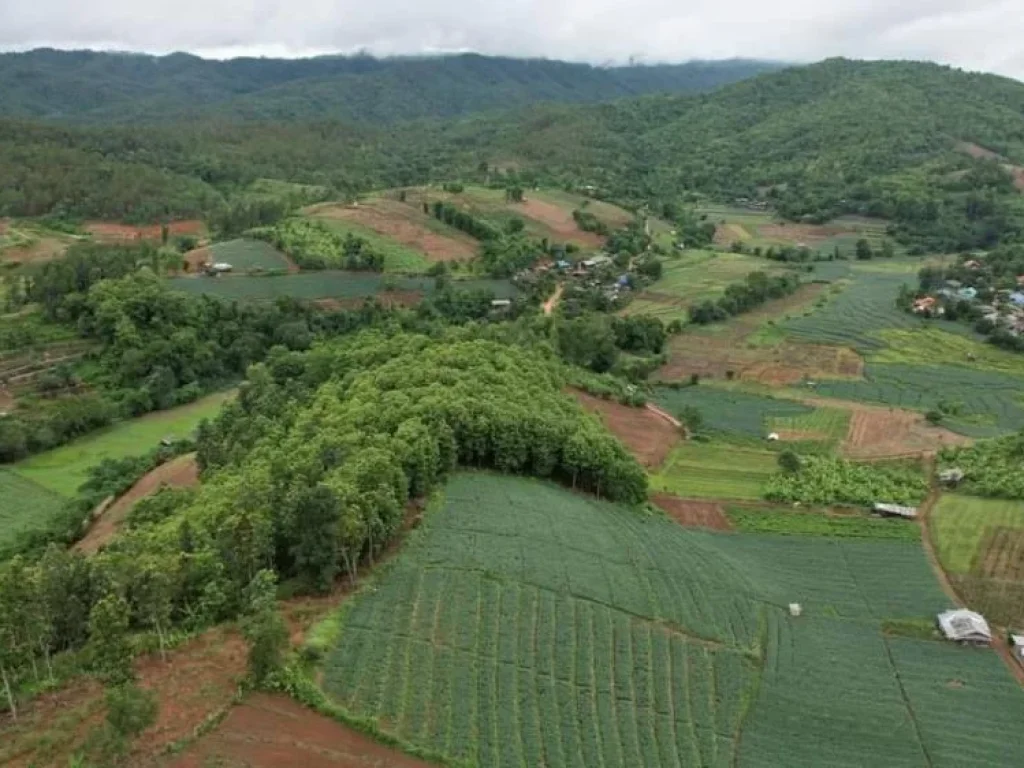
[{"x1": 0, "y1": 49, "x2": 781, "y2": 123}]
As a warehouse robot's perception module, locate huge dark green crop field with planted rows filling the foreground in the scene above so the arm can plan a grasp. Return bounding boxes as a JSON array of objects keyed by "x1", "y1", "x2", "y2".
[{"x1": 313, "y1": 474, "x2": 1024, "y2": 768}]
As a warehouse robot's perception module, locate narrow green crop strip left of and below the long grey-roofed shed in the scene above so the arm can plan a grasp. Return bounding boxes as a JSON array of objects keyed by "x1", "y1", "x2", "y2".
[{"x1": 725, "y1": 507, "x2": 921, "y2": 541}]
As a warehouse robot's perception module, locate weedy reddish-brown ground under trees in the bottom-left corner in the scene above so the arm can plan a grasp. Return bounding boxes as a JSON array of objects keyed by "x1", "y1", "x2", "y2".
[{"x1": 0, "y1": 629, "x2": 247, "y2": 768}]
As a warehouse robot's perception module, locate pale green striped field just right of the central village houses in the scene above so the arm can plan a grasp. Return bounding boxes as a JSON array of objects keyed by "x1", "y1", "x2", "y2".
[{"x1": 623, "y1": 250, "x2": 785, "y2": 323}]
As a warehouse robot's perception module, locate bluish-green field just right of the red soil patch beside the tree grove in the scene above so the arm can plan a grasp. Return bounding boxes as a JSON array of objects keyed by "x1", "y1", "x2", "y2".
[{"x1": 653, "y1": 384, "x2": 815, "y2": 439}]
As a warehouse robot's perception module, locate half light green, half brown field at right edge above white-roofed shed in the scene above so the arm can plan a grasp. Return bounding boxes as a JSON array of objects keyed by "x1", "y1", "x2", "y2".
[{"x1": 929, "y1": 494, "x2": 1024, "y2": 626}]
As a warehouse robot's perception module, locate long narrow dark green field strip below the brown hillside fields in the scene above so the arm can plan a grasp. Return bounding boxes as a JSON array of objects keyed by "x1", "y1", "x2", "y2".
[{"x1": 170, "y1": 270, "x2": 517, "y2": 301}]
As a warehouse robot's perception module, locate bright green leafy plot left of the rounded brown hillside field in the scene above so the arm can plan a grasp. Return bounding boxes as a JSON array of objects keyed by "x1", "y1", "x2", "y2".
[{"x1": 250, "y1": 218, "x2": 384, "y2": 272}]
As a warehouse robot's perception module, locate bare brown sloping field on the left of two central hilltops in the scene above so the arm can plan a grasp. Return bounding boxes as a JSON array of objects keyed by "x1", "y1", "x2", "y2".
[{"x1": 307, "y1": 200, "x2": 477, "y2": 261}]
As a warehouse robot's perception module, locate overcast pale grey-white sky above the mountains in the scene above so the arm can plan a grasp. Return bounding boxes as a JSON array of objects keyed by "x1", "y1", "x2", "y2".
[{"x1": 0, "y1": 0, "x2": 1024, "y2": 80}]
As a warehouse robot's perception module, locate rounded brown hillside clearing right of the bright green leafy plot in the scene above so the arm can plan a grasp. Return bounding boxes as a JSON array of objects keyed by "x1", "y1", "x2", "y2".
[{"x1": 305, "y1": 198, "x2": 479, "y2": 269}]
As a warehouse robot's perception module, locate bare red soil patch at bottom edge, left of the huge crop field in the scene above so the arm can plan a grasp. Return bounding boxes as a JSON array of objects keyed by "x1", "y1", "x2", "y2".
[{"x1": 169, "y1": 693, "x2": 440, "y2": 768}]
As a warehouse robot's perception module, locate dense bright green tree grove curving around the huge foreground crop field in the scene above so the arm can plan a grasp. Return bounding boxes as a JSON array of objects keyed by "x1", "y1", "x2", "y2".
[{"x1": 0, "y1": 330, "x2": 646, "y2": 720}]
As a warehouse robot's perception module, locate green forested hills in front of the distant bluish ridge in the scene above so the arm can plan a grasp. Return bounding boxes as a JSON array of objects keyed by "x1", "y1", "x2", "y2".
[{"x1": 6, "y1": 57, "x2": 1024, "y2": 251}]
